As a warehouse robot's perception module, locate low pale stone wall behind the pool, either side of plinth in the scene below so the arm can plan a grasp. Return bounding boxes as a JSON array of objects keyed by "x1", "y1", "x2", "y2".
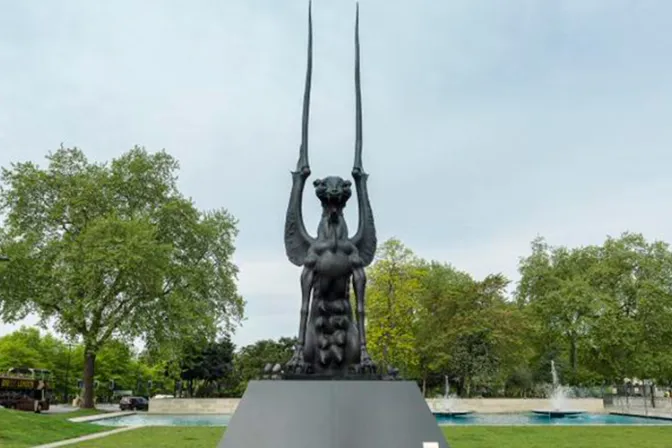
[{"x1": 149, "y1": 398, "x2": 605, "y2": 414}]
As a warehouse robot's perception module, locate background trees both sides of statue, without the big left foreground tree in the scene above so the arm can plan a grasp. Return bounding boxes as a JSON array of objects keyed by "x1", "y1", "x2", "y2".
[{"x1": 0, "y1": 233, "x2": 672, "y2": 399}]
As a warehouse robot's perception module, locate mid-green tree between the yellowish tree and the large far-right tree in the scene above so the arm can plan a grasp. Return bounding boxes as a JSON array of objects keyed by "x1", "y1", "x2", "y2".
[{"x1": 417, "y1": 262, "x2": 525, "y2": 395}]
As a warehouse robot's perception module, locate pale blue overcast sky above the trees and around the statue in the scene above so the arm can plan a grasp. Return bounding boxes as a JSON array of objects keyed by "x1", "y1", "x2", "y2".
[{"x1": 0, "y1": 0, "x2": 672, "y2": 344}]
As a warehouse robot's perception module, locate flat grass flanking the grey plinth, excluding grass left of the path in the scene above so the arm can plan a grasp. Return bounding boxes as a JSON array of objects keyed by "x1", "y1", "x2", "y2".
[{"x1": 67, "y1": 426, "x2": 672, "y2": 448}]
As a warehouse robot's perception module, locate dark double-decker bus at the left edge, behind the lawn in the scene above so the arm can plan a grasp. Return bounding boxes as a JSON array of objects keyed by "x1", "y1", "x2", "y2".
[{"x1": 0, "y1": 368, "x2": 50, "y2": 413}]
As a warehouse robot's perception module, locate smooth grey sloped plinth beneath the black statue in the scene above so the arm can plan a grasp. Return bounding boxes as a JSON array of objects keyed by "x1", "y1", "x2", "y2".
[{"x1": 218, "y1": 379, "x2": 448, "y2": 448}]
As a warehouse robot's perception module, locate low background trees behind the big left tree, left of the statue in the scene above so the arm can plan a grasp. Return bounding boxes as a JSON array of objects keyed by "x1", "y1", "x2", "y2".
[{"x1": 0, "y1": 327, "x2": 296, "y2": 402}]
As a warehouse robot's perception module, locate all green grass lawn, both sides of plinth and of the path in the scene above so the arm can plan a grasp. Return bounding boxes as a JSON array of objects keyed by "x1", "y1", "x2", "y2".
[{"x1": 0, "y1": 409, "x2": 672, "y2": 448}]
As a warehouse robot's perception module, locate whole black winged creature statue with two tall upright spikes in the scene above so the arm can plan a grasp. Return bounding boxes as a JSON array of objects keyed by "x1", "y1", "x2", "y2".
[{"x1": 285, "y1": 1, "x2": 377, "y2": 375}]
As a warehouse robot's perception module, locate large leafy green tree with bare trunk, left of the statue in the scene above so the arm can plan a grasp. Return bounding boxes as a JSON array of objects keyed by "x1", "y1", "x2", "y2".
[{"x1": 0, "y1": 147, "x2": 244, "y2": 407}]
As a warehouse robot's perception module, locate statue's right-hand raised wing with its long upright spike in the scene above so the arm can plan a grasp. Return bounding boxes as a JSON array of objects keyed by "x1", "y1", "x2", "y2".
[{"x1": 350, "y1": 4, "x2": 378, "y2": 266}]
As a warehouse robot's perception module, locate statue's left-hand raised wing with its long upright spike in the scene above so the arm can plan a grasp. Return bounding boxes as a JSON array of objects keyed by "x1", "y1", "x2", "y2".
[{"x1": 285, "y1": 4, "x2": 314, "y2": 266}]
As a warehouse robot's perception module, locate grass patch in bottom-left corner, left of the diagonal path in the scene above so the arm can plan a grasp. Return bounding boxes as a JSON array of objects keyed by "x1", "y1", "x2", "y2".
[{"x1": 0, "y1": 409, "x2": 110, "y2": 448}]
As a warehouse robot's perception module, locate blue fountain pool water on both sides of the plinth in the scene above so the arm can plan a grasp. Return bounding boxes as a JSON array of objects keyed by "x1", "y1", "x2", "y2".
[{"x1": 92, "y1": 413, "x2": 672, "y2": 426}]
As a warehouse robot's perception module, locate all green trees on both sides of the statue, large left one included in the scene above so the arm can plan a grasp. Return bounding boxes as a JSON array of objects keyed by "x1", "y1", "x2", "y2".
[{"x1": 0, "y1": 147, "x2": 672, "y2": 407}]
